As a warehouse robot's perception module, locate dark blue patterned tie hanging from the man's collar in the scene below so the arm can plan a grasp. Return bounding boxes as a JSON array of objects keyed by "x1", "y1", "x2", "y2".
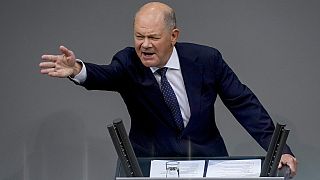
[{"x1": 156, "y1": 67, "x2": 184, "y2": 131}]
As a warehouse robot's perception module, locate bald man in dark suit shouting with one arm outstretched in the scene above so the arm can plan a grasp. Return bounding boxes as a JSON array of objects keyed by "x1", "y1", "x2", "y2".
[{"x1": 40, "y1": 2, "x2": 297, "y2": 176}]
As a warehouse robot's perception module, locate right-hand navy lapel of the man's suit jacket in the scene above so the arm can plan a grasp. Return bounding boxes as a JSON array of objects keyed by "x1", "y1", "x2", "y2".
[{"x1": 176, "y1": 44, "x2": 203, "y2": 133}]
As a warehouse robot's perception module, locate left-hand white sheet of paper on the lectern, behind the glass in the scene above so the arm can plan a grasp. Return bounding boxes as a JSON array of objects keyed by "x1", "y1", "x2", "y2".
[{"x1": 150, "y1": 160, "x2": 205, "y2": 178}]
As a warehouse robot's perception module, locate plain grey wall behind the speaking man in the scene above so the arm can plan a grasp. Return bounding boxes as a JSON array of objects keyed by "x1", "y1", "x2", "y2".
[{"x1": 0, "y1": 0, "x2": 320, "y2": 180}]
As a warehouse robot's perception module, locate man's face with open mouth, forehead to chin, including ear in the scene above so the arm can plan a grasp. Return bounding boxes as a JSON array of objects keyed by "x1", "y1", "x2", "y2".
[{"x1": 134, "y1": 13, "x2": 178, "y2": 68}]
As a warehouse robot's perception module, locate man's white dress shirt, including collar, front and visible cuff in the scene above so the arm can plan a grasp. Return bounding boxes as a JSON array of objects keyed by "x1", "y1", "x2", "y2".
[{"x1": 72, "y1": 47, "x2": 191, "y2": 127}]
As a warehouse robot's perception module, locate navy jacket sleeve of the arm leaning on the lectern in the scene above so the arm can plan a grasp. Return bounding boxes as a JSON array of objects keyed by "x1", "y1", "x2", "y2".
[{"x1": 215, "y1": 52, "x2": 292, "y2": 154}]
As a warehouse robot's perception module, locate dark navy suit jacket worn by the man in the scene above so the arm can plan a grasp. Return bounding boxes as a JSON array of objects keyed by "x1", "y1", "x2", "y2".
[{"x1": 82, "y1": 43, "x2": 290, "y2": 157}]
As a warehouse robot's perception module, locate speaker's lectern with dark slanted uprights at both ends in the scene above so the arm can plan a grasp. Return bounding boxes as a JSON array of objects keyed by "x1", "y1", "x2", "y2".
[{"x1": 107, "y1": 119, "x2": 290, "y2": 180}]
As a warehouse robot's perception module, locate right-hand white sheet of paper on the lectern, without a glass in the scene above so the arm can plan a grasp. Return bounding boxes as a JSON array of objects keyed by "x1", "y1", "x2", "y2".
[{"x1": 206, "y1": 159, "x2": 261, "y2": 178}]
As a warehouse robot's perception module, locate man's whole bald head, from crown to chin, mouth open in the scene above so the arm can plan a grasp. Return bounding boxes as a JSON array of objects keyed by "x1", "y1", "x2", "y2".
[{"x1": 134, "y1": 2, "x2": 179, "y2": 68}]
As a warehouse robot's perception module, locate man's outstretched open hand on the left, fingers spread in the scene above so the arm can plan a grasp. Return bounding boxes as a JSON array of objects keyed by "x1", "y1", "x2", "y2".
[{"x1": 39, "y1": 46, "x2": 82, "y2": 78}]
